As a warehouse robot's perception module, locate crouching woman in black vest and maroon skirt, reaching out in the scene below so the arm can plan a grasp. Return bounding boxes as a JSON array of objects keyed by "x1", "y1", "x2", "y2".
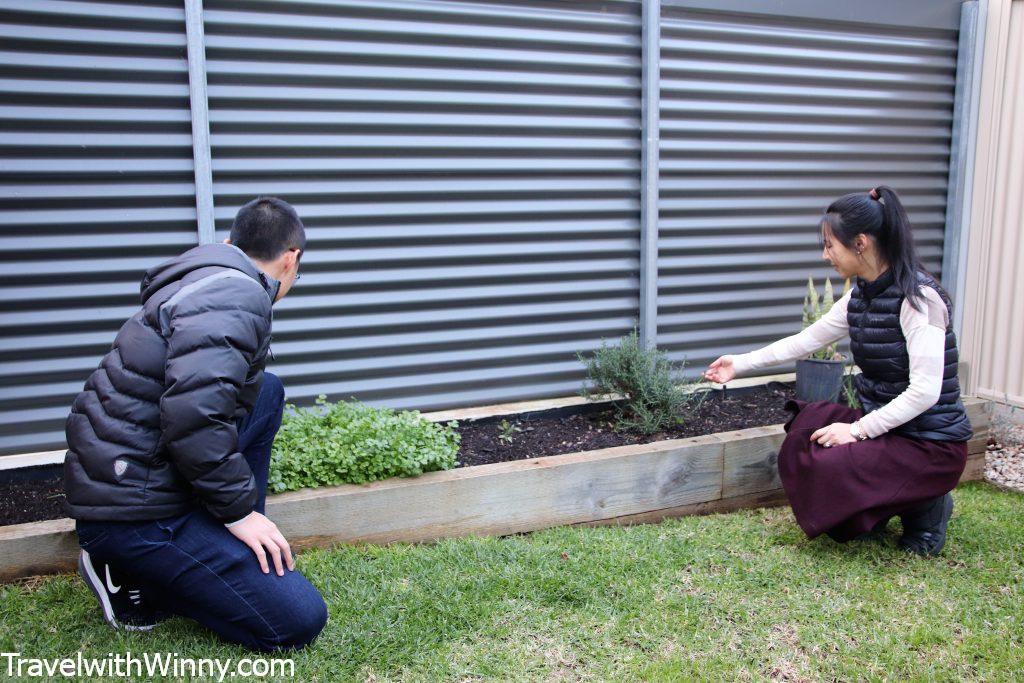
[{"x1": 705, "y1": 186, "x2": 972, "y2": 555}]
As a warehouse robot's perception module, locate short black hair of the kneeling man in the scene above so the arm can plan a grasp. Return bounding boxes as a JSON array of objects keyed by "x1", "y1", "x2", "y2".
[{"x1": 231, "y1": 197, "x2": 306, "y2": 261}]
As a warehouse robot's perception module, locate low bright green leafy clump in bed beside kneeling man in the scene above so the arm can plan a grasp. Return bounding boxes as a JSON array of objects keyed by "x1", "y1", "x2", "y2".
[{"x1": 268, "y1": 395, "x2": 461, "y2": 493}]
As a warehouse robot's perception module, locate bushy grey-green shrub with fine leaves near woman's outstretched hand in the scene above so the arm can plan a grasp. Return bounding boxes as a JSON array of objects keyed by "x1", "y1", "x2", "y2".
[{"x1": 577, "y1": 329, "x2": 707, "y2": 434}]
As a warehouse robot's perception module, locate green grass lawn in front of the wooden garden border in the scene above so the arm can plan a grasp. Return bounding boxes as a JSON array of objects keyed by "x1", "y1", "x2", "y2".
[{"x1": 0, "y1": 483, "x2": 1024, "y2": 681}]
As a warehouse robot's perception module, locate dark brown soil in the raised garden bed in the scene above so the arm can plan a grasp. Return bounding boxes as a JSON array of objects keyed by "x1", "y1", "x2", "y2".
[{"x1": 0, "y1": 382, "x2": 806, "y2": 526}]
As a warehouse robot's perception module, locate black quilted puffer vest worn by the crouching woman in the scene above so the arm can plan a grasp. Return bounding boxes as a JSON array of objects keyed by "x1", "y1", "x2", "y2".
[{"x1": 847, "y1": 270, "x2": 973, "y2": 441}]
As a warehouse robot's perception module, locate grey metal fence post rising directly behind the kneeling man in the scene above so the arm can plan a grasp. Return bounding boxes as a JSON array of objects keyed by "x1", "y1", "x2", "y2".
[{"x1": 185, "y1": 0, "x2": 216, "y2": 244}]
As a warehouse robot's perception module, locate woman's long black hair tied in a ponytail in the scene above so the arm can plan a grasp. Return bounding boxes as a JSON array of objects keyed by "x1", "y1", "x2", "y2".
[{"x1": 821, "y1": 185, "x2": 928, "y2": 310}]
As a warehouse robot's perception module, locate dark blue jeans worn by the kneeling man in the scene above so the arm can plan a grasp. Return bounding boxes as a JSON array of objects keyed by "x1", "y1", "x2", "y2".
[{"x1": 78, "y1": 373, "x2": 327, "y2": 651}]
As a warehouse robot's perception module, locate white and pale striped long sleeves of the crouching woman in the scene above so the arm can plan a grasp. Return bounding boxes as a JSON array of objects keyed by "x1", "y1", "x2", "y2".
[{"x1": 732, "y1": 287, "x2": 949, "y2": 438}]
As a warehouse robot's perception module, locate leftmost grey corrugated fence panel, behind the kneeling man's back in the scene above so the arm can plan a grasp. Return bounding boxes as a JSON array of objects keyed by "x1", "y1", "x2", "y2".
[{"x1": 0, "y1": 0, "x2": 197, "y2": 455}]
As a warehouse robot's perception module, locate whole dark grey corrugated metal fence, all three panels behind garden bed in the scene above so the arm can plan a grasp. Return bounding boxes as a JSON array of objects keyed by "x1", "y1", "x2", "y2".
[{"x1": 0, "y1": 0, "x2": 958, "y2": 454}]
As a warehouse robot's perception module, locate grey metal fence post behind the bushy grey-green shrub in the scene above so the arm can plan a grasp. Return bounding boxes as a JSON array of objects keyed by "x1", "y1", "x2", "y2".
[{"x1": 639, "y1": 0, "x2": 662, "y2": 348}]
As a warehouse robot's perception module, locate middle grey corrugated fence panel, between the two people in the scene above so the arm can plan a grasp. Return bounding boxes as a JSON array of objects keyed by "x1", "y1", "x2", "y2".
[{"x1": 205, "y1": 0, "x2": 640, "y2": 409}]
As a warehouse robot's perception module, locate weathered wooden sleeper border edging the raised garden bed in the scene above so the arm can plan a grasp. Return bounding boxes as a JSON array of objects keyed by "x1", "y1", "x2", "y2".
[{"x1": 0, "y1": 398, "x2": 991, "y2": 582}]
